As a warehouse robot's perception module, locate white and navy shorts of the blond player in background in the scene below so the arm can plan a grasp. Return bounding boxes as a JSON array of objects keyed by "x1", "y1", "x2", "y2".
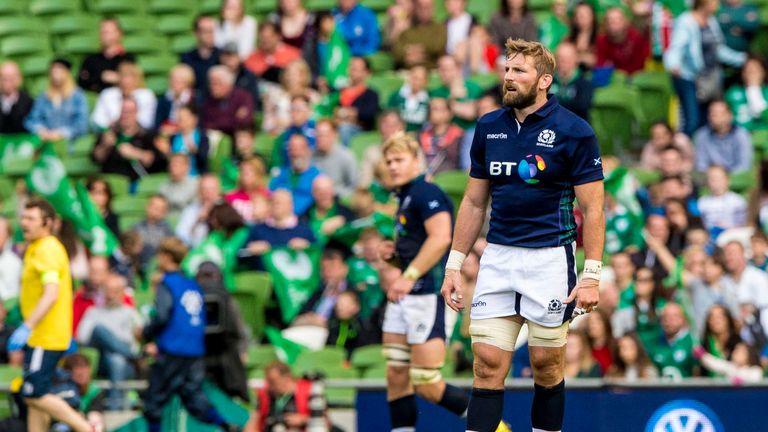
[{"x1": 382, "y1": 294, "x2": 457, "y2": 345}]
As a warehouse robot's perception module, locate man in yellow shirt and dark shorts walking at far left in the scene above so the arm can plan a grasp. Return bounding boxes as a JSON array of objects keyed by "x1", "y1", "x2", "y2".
[{"x1": 8, "y1": 198, "x2": 92, "y2": 432}]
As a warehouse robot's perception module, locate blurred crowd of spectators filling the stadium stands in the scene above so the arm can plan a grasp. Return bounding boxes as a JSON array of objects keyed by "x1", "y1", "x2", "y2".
[{"x1": 0, "y1": 0, "x2": 768, "y2": 426}]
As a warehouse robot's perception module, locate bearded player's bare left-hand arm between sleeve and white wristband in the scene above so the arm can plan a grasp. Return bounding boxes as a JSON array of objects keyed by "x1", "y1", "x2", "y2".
[{"x1": 451, "y1": 177, "x2": 488, "y2": 255}]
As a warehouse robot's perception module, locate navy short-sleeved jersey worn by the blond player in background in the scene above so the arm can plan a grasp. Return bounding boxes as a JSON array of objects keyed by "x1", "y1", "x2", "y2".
[{"x1": 395, "y1": 176, "x2": 453, "y2": 294}]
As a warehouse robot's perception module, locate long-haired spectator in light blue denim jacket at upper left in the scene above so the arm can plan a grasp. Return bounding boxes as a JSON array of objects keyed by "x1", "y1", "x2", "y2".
[{"x1": 24, "y1": 59, "x2": 88, "y2": 141}]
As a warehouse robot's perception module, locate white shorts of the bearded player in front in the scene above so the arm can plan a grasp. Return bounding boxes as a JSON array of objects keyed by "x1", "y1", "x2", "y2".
[{"x1": 470, "y1": 243, "x2": 576, "y2": 327}]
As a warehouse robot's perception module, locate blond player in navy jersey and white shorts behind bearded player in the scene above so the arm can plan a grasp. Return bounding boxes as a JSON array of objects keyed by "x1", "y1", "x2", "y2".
[{"x1": 381, "y1": 132, "x2": 468, "y2": 432}]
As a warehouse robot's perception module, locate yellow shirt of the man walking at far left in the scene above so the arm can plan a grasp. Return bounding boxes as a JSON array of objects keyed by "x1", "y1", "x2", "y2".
[{"x1": 19, "y1": 236, "x2": 72, "y2": 351}]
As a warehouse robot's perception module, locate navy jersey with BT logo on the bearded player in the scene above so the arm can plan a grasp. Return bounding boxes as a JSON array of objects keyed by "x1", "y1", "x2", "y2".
[{"x1": 469, "y1": 96, "x2": 603, "y2": 248}]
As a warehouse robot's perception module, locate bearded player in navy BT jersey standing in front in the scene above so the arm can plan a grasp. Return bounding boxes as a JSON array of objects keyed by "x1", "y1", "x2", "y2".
[{"x1": 441, "y1": 39, "x2": 605, "y2": 432}]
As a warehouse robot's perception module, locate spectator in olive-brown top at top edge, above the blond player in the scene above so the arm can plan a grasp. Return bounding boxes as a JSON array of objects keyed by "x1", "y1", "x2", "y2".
[{"x1": 392, "y1": 0, "x2": 447, "y2": 68}]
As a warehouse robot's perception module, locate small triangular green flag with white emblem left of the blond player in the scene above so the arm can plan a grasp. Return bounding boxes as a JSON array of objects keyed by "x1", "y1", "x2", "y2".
[{"x1": 261, "y1": 247, "x2": 320, "y2": 324}]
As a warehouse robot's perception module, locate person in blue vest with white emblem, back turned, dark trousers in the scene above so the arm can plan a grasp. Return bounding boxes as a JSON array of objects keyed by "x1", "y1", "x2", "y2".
[{"x1": 142, "y1": 238, "x2": 239, "y2": 432}]
